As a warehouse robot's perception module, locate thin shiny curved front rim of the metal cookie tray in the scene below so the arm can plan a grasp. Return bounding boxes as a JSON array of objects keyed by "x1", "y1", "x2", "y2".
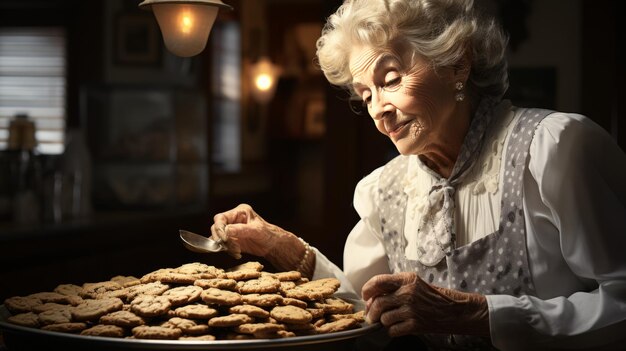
[{"x1": 0, "y1": 304, "x2": 382, "y2": 350}]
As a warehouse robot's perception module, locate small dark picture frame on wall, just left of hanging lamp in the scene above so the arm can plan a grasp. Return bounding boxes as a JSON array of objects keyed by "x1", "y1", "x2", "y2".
[{"x1": 113, "y1": 13, "x2": 162, "y2": 67}]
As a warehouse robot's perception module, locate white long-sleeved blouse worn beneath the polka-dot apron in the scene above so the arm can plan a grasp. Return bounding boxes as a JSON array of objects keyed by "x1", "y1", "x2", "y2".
[{"x1": 314, "y1": 102, "x2": 626, "y2": 350}]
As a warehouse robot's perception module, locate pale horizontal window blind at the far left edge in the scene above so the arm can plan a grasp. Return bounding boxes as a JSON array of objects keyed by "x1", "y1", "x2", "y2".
[{"x1": 0, "y1": 27, "x2": 67, "y2": 154}]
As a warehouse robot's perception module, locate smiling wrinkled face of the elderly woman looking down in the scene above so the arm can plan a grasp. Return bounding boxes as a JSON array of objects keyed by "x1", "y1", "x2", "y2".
[{"x1": 350, "y1": 47, "x2": 463, "y2": 158}]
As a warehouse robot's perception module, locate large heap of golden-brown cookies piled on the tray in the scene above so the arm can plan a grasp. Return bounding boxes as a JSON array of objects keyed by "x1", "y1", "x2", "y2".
[{"x1": 4, "y1": 261, "x2": 364, "y2": 340}]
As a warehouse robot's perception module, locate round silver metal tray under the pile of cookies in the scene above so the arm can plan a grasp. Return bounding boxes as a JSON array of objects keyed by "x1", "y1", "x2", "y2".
[{"x1": 0, "y1": 305, "x2": 381, "y2": 351}]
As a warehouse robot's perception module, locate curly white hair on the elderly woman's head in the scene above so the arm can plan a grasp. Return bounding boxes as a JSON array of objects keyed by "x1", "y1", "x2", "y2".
[{"x1": 316, "y1": 0, "x2": 509, "y2": 97}]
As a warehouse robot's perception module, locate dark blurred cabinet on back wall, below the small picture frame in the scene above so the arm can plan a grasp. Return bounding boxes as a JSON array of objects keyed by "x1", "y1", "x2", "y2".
[{"x1": 82, "y1": 85, "x2": 209, "y2": 209}]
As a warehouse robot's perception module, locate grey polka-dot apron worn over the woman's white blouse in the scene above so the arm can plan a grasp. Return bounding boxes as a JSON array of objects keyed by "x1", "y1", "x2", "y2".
[{"x1": 378, "y1": 109, "x2": 552, "y2": 350}]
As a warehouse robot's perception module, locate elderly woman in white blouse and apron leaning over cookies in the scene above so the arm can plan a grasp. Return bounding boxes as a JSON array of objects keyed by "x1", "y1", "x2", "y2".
[{"x1": 211, "y1": 0, "x2": 626, "y2": 350}]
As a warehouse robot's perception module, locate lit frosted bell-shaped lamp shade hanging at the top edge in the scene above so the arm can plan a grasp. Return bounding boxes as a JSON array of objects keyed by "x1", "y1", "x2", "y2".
[{"x1": 139, "y1": 0, "x2": 232, "y2": 57}]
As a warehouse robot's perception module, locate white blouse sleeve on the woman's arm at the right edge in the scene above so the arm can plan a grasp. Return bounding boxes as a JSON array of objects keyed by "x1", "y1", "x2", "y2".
[{"x1": 487, "y1": 113, "x2": 626, "y2": 350}]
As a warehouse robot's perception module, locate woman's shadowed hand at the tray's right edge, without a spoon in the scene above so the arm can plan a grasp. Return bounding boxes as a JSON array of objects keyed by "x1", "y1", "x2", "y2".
[{"x1": 362, "y1": 272, "x2": 489, "y2": 337}]
